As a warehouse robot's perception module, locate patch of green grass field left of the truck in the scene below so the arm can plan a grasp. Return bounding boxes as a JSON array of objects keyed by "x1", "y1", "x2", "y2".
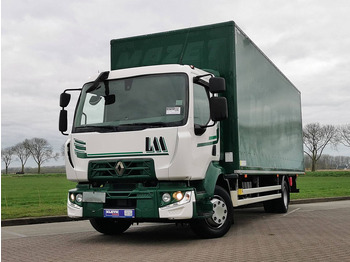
[{"x1": 1, "y1": 174, "x2": 76, "y2": 219}]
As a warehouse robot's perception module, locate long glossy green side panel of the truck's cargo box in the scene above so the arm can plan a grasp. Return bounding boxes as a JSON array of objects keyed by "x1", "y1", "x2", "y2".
[{"x1": 236, "y1": 29, "x2": 304, "y2": 172}]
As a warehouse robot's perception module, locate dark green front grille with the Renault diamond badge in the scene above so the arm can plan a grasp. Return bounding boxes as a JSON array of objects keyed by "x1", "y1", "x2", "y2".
[{"x1": 88, "y1": 159, "x2": 156, "y2": 181}]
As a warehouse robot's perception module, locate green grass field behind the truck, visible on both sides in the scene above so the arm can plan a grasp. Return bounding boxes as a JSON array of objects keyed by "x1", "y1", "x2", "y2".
[{"x1": 1, "y1": 171, "x2": 350, "y2": 220}]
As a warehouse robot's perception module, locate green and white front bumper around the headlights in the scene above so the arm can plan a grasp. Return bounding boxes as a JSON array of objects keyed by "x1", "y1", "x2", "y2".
[{"x1": 67, "y1": 188, "x2": 197, "y2": 221}]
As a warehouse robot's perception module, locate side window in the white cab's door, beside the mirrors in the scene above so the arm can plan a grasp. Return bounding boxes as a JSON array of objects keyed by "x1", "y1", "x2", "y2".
[{"x1": 193, "y1": 84, "x2": 210, "y2": 126}]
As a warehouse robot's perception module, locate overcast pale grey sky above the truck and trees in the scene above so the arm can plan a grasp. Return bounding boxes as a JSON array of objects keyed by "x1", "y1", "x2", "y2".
[{"x1": 1, "y1": 0, "x2": 350, "y2": 166}]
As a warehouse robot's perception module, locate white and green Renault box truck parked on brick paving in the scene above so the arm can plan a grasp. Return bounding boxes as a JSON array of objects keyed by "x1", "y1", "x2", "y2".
[{"x1": 59, "y1": 21, "x2": 304, "y2": 238}]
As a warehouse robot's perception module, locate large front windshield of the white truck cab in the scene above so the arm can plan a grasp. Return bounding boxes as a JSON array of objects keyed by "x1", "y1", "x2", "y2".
[{"x1": 73, "y1": 74, "x2": 188, "y2": 133}]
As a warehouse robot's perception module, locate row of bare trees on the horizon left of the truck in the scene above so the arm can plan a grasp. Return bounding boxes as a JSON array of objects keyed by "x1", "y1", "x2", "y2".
[{"x1": 1, "y1": 137, "x2": 60, "y2": 174}]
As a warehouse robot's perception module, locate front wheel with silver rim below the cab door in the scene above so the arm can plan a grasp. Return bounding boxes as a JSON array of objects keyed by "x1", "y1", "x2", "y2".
[{"x1": 190, "y1": 186, "x2": 233, "y2": 238}]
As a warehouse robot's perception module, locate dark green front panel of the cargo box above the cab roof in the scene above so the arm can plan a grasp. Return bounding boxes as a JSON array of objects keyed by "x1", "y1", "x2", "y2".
[{"x1": 111, "y1": 22, "x2": 234, "y2": 74}]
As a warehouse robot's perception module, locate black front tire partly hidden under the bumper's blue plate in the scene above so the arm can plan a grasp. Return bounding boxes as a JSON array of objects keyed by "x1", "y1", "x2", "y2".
[{"x1": 90, "y1": 218, "x2": 131, "y2": 235}]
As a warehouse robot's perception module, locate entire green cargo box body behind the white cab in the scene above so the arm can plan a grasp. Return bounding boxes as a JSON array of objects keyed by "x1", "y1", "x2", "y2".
[{"x1": 111, "y1": 21, "x2": 304, "y2": 174}]
